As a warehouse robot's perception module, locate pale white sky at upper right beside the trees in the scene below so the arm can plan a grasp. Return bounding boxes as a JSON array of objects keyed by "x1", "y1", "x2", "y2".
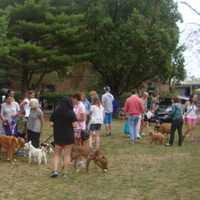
[{"x1": 177, "y1": 0, "x2": 200, "y2": 78}]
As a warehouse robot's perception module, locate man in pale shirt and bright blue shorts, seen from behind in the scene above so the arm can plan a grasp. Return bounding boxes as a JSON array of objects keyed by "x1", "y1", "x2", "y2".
[{"x1": 102, "y1": 86, "x2": 114, "y2": 136}]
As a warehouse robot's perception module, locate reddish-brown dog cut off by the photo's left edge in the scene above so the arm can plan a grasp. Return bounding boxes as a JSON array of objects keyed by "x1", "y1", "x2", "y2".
[{"x1": 0, "y1": 135, "x2": 20, "y2": 161}]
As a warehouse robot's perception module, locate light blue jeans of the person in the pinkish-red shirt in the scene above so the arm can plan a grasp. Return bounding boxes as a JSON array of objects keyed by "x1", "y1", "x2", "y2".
[{"x1": 128, "y1": 116, "x2": 139, "y2": 142}]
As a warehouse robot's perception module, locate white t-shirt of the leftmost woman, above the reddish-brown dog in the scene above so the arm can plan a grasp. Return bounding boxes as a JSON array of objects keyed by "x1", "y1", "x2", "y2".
[{"x1": 1, "y1": 101, "x2": 20, "y2": 122}]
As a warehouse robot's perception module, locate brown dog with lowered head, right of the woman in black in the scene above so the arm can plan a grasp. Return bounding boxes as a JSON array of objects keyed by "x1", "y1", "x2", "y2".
[{"x1": 71, "y1": 145, "x2": 108, "y2": 172}]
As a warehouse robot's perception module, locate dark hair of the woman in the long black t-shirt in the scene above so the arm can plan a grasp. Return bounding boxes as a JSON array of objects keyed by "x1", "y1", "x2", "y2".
[{"x1": 55, "y1": 97, "x2": 73, "y2": 115}]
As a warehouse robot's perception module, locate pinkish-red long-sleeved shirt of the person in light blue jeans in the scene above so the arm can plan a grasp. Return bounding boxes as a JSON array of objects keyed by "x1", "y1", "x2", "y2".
[{"x1": 124, "y1": 95, "x2": 144, "y2": 116}]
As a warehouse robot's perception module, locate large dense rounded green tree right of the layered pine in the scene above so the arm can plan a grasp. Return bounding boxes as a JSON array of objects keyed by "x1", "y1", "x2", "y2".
[{"x1": 86, "y1": 0, "x2": 184, "y2": 97}]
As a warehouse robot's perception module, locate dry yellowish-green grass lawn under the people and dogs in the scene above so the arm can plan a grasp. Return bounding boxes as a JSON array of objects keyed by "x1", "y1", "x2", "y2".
[{"x1": 0, "y1": 121, "x2": 200, "y2": 200}]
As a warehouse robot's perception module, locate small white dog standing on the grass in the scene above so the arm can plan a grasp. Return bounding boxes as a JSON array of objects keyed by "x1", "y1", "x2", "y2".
[{"x1": 25, "y1": 141, "x2": 47, "y2": 165}]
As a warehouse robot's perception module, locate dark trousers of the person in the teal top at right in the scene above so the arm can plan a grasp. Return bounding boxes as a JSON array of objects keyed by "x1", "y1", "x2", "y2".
[{"x1": 169, "y1": 119, "x2": 183, "y2": 146}]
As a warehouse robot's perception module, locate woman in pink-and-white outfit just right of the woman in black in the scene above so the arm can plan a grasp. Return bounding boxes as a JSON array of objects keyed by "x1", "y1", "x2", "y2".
[{"x1": 72, "y1": 93, "x2": 87, "y2": 145}]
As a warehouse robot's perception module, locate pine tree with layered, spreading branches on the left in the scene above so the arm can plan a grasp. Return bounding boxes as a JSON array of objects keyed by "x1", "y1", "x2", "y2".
[{"x1": 0, "y1": 0, "x2": 87, "y2": 93}]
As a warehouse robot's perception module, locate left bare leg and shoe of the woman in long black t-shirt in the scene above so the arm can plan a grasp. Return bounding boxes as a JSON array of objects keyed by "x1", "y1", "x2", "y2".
[{"x1": 51, "y1": 145, "x2": 62, "y2": 177}]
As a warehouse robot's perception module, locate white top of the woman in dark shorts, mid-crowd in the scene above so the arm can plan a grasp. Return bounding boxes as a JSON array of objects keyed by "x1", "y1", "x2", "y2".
[{"x1": 90, "y1": 105, "x2": 104, "y2": 124}]
